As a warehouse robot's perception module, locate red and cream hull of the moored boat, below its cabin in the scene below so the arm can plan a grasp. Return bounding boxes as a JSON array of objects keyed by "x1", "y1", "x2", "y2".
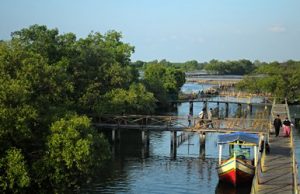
[{"x1": 217, "y1": 157, "x2": 255, "y2": 185}]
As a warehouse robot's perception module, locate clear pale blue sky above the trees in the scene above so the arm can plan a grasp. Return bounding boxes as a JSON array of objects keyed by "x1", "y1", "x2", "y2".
[{"x1": 0, "y1": 0, "x2": 300, "y2": 62}]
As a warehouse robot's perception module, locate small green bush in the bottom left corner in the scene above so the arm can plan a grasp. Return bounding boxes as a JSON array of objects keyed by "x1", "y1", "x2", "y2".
[{"x1": 0, "y1": 147, "x2": 30, "y2": 193}]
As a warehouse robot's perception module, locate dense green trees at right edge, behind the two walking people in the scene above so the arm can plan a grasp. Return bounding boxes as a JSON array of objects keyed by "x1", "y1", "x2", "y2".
[{"x1": 238, "y1": 61, "x2": 300, "y2": 102}]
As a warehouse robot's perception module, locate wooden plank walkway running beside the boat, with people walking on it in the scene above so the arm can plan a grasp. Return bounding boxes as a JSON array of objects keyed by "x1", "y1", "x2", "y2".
[{"x1": 251, "y1": 104, "x2": 294, "y2": 194}]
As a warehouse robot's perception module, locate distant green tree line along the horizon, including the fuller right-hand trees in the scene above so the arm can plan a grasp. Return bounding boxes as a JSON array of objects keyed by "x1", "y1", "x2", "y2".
[{"x1": 135, "y1": 59, "x2": 300, "y2": 103}]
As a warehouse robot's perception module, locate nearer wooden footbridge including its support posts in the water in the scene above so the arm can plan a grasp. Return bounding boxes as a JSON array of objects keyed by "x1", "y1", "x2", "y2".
[{"x1": 93, "y1": 114, "x2": 271, "y2": 158}]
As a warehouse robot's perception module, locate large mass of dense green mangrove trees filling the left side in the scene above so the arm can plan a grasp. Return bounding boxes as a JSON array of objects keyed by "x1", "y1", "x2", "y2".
[{"x1": 0, "y1": 25, "x2": 185, "y2": 193}]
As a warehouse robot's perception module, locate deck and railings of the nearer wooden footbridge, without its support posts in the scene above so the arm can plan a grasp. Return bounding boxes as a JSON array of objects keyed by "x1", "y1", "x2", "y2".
[{"x1": 94, "y1": 115, "x2": 271, "y2": 133}]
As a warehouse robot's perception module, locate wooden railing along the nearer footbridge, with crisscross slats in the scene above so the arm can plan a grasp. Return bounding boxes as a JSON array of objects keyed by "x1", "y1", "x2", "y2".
[{"x1": 93, "y1": 115, "x2": 270, "y2": 133}]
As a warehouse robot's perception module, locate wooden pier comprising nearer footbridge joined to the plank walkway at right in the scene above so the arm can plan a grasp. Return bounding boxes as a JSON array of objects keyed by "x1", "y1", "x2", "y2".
[{"x1": 93, "y1": 101, "x2": 298, "y2": 190}]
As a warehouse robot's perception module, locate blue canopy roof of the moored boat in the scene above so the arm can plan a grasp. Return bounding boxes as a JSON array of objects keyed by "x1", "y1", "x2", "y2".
[{"x1": 218, "y1": 132, "x2": 259, "y2": 145}]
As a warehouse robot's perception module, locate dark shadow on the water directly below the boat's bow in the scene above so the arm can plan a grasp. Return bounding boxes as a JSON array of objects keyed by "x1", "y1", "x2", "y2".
[{"x1": 215, "y1": 181, "x2": 251, "y2": 194}]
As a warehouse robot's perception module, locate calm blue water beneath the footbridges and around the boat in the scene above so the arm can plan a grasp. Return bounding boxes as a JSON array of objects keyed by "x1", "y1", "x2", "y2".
[{"x1": 80, "y1": 84, "x2": 300, "y2": 194}]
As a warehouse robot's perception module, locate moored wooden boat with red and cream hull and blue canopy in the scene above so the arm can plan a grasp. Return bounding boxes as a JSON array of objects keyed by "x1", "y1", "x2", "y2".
[{"x1": 217, "y1": 132, "x2": 259, "y2": 186}]
